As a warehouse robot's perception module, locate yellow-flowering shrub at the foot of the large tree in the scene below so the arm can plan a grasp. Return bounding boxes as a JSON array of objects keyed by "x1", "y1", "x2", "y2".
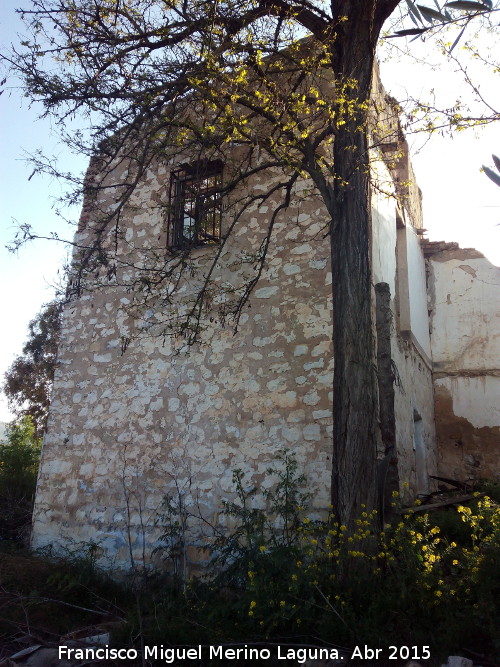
[{"x1": 200, "y1": 453, "x2": 500, "y2": 657}]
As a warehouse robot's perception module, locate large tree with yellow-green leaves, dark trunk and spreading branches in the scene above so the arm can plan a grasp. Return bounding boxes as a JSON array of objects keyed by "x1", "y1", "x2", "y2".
[{"x1": 1, "y1": 0, "x2": 498, "y2": 522}]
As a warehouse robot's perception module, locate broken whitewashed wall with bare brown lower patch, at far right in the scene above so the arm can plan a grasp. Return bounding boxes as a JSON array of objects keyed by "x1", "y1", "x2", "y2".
[{"x1": 425, "y1": 243, "x2": 500, "y2": 481}]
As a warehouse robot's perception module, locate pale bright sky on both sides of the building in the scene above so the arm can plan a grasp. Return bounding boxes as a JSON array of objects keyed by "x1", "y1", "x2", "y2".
[{"x1": 0, "y1": 0, "x2": 500, "y2": 422}]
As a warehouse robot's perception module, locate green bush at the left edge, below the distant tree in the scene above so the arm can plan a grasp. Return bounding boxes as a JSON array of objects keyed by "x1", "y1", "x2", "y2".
[{"x1": 0, "y1": 417, "x2": 41, "y2": 541}]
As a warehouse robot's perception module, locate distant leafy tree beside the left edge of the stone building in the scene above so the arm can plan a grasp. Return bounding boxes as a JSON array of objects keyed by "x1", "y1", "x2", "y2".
[{"x1": 3, "y1": 300, "x2": 62, "y2": 437}]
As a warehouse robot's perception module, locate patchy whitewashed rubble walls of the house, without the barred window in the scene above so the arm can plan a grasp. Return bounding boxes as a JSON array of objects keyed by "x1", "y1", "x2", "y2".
[{"x1": 33, "y1": 138, "x2": 434, "y2": 567}]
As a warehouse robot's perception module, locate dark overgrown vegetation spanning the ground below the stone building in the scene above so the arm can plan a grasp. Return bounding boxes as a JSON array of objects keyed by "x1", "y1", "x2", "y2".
[{"x1": 0, "y1": 452, "x2": 500, "y2": 665}]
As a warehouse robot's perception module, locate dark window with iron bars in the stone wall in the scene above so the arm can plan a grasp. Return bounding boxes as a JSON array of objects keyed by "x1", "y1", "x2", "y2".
[{"x1": 167, "y1": 160, "x2": 223, "y2": 250}]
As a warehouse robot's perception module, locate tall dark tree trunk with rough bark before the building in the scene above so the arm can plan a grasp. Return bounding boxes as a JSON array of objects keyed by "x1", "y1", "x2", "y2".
[{"x1": 330, "y1": 0, "x2": 397, "y2": 525}]
